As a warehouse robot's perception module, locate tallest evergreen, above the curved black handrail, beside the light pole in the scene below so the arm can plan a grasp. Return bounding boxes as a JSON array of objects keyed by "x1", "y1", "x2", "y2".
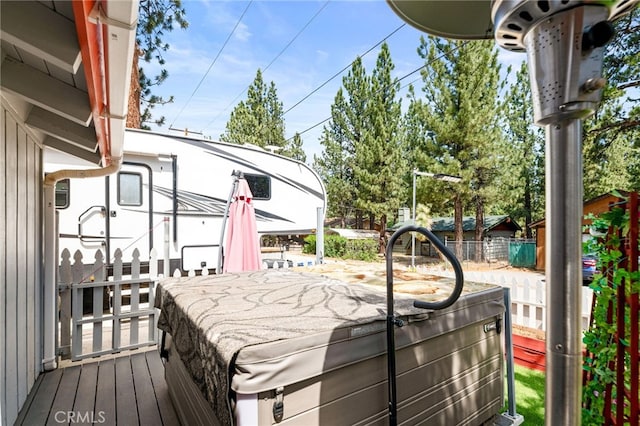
[{"x1": 418, "y1": 37, "x2": 501, "y2": 257}]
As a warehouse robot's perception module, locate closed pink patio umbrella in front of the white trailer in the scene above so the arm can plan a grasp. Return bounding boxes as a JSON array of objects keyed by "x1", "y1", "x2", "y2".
[{"x1": 223, "y1": 178, "x2": 261, "y2": 273}]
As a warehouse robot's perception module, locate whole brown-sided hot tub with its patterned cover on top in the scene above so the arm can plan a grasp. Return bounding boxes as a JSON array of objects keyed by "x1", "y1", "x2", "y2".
[{"x1": 156, "y1": 270, "x2": 505, "y2": 426}]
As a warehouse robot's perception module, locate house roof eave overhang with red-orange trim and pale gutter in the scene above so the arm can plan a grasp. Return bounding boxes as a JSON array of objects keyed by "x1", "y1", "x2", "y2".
[{"x1": 0, "y1": 0, "x2": 138, "y2": 166}]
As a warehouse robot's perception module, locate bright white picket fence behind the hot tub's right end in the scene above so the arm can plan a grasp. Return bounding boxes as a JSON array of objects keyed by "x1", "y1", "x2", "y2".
[{"x1": 424, "y1": 271, "x2": 593, "y2": 331}]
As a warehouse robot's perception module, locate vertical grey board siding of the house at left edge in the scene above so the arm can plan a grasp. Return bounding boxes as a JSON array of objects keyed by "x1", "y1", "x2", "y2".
[{"x1": 0, "y1": 97, "x2": 42, "y2": 424}]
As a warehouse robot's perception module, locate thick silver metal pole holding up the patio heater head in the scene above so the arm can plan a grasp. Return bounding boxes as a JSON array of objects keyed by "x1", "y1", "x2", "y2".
[{"x1": 545, "y1": 119, "x2": 582, "y2": 426}]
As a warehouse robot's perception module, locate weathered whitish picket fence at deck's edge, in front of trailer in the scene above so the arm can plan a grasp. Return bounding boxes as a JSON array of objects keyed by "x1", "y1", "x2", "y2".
[{"x1": 56, "y1": 249, "x2": 158, "y2": 360}]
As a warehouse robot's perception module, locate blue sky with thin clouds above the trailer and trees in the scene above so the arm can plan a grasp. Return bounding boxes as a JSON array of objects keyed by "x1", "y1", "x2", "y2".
[{"x1": 143, "y1": 0, "x2": 526, "y2": 163}]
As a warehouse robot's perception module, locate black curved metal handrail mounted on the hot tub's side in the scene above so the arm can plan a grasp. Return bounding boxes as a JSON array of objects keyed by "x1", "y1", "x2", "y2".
[{"x1": 386, "y1": 225, "x2": 464, "y2": 426}]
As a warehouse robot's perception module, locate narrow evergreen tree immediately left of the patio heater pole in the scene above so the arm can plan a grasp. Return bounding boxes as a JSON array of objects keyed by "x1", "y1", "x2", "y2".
[{"x1": 496, "y1": 62, "x2": 544, "y2": 238}]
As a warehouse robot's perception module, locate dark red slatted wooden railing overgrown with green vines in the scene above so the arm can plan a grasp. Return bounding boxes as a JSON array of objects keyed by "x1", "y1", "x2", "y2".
[{"x1": 583, "y1": 192, "x2": 640, "y2": 426}]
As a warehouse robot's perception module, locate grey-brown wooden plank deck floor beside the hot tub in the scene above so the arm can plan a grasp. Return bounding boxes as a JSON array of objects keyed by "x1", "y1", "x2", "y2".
[{"x1": 15, "y1": 348, "x2": 180, "y2": 426}]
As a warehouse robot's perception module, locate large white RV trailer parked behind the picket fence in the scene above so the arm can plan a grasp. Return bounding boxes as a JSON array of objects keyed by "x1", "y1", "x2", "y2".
[{"x1": 44, "y1": 129, "x2": 326, "y2": 272}]
